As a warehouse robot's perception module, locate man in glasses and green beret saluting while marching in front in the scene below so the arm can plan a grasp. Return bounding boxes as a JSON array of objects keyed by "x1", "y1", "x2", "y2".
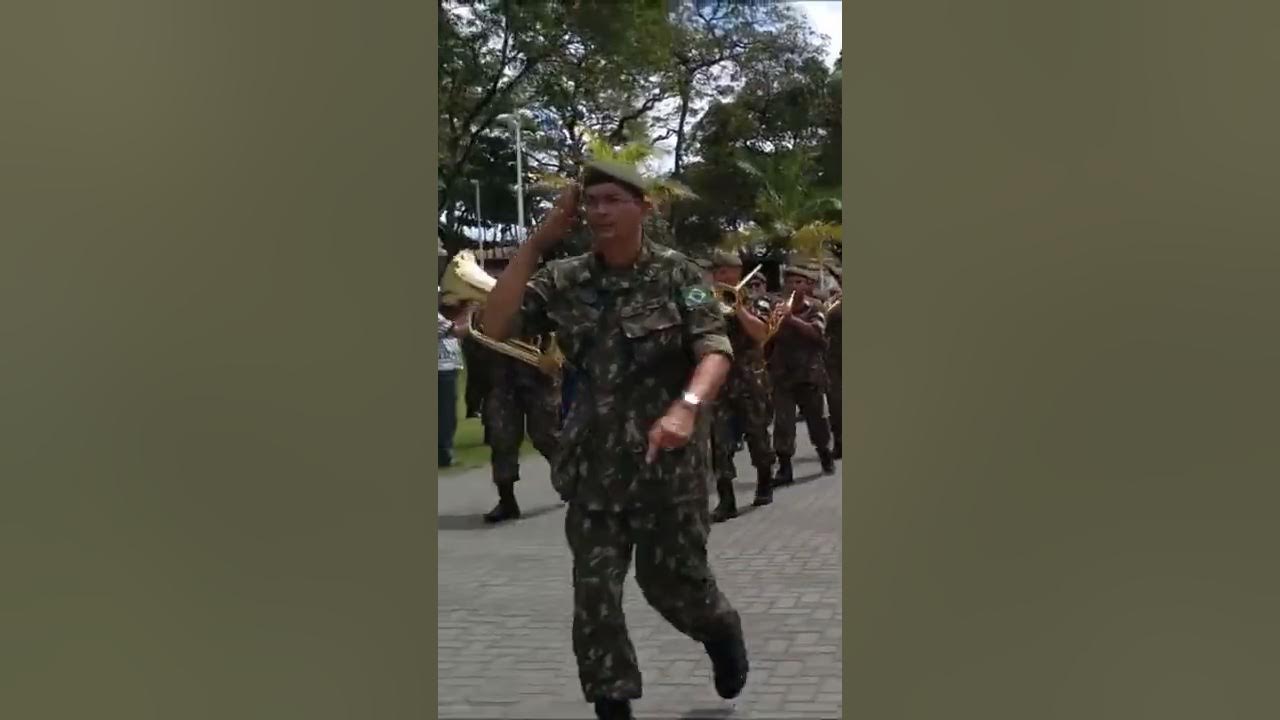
[{"x1": 483, "y1": 163, "x2": 748, "y2": 719}]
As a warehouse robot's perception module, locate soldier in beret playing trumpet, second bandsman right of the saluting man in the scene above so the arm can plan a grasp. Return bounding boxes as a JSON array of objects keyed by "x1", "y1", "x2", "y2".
[{"x1": 767, "y1": 260, "x2": 836, "y2": 486}]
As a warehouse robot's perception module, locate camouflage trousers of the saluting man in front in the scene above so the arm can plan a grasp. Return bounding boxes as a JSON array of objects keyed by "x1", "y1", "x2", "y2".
[{"x1": 564, "y1": 501, "x2": 742, "y2": 702}]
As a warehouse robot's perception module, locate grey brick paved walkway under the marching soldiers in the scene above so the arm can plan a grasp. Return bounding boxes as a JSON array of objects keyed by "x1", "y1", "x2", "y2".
[{"x1": 438, "y1": 427, "x2": 841, "y2": 720}]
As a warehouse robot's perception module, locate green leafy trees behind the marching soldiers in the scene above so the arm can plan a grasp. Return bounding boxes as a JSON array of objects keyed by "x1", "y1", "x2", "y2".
[{"x1": 438, "y1": 0, "x2": 842, "y2": 252}]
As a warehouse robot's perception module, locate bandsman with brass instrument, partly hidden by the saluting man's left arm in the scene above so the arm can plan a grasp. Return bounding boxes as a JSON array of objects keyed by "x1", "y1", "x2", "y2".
[{"x1": 710, "y1": 251, "x2": 773, "y2": 523}]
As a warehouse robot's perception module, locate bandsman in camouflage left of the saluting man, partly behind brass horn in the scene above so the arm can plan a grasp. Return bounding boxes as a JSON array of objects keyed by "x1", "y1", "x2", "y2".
[{"x1": 458, "y1": 313, "x2": 561, "y2": 523}]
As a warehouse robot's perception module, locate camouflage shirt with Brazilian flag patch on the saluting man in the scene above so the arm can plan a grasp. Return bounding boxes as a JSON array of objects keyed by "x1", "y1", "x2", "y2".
[{"x1": 506, "y1": 240, "x2": 732, "y2": 511}]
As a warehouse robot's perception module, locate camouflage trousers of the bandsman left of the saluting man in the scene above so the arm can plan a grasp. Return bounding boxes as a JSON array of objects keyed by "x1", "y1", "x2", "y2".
[{"x1": 484, "y1": 378, "x2": 561, "y2": 483}]
